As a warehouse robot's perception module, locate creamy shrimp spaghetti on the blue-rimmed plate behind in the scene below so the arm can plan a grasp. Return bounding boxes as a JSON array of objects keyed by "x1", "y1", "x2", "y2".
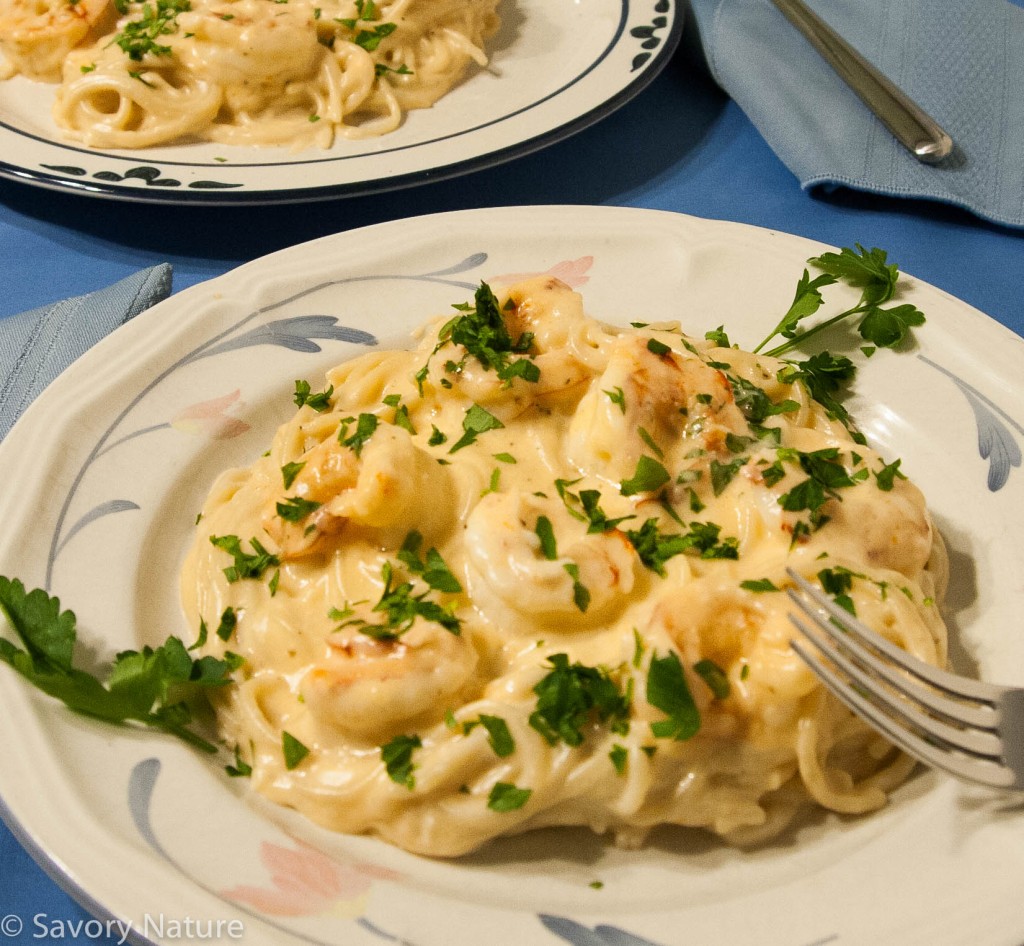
[{"x1": 0, "y1": 0, "x2": 499, "y2": 149}]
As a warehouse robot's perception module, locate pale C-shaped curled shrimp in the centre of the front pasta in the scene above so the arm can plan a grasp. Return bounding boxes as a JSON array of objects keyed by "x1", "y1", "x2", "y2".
[{"x1": 465, "y1": 491, "x2": 637, "y2": 625}]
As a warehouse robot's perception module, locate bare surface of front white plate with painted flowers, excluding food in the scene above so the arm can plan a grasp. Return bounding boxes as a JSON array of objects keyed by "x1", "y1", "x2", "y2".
[{"x1": 0, "y1": 207, "x2": 1024, "y2": 946}]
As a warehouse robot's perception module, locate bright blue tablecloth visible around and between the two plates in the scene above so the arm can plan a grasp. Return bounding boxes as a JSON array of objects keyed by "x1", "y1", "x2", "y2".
[{"x1": 0, "y1": 24, "x2": 1024, "y2": 944}]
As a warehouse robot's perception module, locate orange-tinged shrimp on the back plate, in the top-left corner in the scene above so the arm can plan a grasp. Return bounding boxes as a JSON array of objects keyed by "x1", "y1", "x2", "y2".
[{"x1": 0, "y1": 0, "x2": 116, "y2": 82}]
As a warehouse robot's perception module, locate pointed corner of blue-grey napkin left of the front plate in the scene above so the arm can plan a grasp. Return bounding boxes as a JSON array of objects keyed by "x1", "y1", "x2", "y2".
[{"x1": 0, "y1": 263, "x2": 172, "y2": 439}]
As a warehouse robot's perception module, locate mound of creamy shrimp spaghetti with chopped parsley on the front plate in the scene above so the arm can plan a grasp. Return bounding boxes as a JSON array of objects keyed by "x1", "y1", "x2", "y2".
[{"x1": 182, "y1": 276, "x2": 946, "y2": 856}]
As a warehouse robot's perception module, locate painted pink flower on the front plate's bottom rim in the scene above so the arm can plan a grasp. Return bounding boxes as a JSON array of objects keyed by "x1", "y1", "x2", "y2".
[{"x1": 221, "y1": 841, "x2": 398, "y2": 918}]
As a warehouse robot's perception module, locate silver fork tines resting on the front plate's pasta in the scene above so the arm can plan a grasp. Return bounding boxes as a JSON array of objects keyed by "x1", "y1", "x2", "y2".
[{"x1": 787, "y1": 569, "x2": 1024, "y2": 790}]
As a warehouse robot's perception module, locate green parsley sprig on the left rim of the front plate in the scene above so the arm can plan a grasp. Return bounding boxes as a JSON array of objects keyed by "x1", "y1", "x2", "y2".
[{"x1": 0, "y1": 575, "x2": 242, "y2": 753}]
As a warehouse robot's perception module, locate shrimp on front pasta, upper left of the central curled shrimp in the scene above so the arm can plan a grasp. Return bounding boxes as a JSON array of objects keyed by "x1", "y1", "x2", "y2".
[{"x1": 263, "y1": 424, "x2": 455, "y2": 560}]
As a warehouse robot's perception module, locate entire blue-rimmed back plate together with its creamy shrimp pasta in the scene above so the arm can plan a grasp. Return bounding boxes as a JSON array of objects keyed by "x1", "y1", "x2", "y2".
[{"x1": 0, "y1": 0, "x2": 684, "y2": 204}]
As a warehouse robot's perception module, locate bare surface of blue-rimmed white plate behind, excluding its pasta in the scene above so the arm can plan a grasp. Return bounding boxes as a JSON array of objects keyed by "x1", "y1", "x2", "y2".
[{"x1": 0, "y1": 0, "x2": 685, "y2": 205}]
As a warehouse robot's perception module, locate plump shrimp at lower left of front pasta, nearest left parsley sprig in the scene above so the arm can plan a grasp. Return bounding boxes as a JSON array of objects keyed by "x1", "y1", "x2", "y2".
[{"x1": 299, "y1": 618, "x2": 477, "y2": 738}]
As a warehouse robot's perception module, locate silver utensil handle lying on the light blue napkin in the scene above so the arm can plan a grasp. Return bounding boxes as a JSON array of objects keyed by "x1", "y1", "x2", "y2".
[{"x1": 772, "y1": 0, "x2": 953, "y2": 164}]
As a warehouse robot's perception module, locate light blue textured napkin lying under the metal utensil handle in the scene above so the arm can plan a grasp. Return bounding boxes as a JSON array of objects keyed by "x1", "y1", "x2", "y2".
[{"x1": 690, "y1": 0, "x2": 1024, "y2": 226}]
